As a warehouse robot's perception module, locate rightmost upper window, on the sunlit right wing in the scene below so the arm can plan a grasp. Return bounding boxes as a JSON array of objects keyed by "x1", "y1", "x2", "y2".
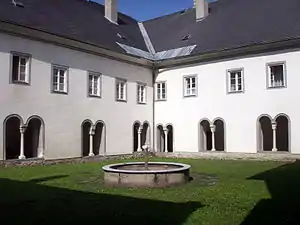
[{"x1": 268, "y1": 63, "x2": 286, "y2": 88}]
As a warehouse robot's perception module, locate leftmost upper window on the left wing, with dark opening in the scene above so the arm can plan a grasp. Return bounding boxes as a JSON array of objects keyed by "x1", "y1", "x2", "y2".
[{"x1": 11, "y1": 53, "x2": 30, "y2": 84}]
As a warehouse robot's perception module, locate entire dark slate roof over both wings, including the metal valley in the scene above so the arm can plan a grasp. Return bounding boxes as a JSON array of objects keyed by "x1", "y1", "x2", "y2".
[{"x1": 0, "y1": 0, "x2": 300, "y2": 60}]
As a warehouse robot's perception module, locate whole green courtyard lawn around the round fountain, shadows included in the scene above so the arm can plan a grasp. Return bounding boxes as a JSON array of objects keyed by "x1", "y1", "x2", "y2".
[{"x1": 0, "y1": 159, "x2": 300, "y2": 225}]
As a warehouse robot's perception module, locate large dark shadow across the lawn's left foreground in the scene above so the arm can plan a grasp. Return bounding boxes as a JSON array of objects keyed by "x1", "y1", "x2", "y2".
[{"x1": 0, "y1": 176, "x2": 203, "y2": 225}]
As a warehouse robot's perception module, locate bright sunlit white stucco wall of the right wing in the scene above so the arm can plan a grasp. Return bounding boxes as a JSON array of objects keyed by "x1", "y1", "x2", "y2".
[{"x1": 155, "y1": 49, "x2": 300, "y2": 153}]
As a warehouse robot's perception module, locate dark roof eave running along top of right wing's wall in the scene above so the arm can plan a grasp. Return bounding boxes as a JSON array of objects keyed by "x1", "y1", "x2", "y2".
[{"x1": 155, "y1": 38, "x2": 300, "y2": 69}]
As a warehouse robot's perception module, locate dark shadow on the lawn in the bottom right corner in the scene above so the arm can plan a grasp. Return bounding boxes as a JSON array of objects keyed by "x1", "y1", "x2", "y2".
[{"x1": 241, "y1": 161, "x2": 300, "y2": 225}]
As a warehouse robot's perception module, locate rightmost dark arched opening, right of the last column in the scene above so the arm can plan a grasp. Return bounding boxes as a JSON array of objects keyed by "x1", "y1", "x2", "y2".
[{"x1": 276, "y1": 115, "x2": 289, "y2": 152}]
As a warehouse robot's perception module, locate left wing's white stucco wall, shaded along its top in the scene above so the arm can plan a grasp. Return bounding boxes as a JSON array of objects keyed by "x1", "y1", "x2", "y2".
[{"x1": 0, "y1": 33, "x2": 153, "y2": 159}]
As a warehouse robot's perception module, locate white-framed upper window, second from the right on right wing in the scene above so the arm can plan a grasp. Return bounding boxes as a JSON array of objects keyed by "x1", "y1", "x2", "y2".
[{"x1": 227, "y1": 69, "x2": 244, "y2": 93}]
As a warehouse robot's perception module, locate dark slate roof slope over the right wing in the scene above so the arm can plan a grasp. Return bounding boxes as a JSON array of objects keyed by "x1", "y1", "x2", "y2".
[{"x1": 144, "y1": 0, "x2": 300, "y2": 54}]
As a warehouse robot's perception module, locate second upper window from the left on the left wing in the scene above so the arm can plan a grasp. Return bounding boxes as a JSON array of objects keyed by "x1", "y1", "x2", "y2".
[{"x1": 52, "y1": 66, "x2": 68, "y2": 93}]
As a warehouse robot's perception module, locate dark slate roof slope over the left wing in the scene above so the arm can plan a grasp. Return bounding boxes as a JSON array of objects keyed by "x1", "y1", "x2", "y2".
[{"x1": 0, "y1": 0, "x2": 147, "y2": 53}]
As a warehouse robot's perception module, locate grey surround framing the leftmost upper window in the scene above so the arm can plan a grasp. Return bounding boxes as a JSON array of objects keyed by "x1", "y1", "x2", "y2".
[{"x1": 9, "y1": 51, "x2": 32, "y2": 85}]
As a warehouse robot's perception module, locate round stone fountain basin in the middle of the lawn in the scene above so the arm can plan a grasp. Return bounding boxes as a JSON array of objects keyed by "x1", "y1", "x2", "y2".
[{"x1": 103, "y1": 162, "x2": 191, "y2": 187}]
